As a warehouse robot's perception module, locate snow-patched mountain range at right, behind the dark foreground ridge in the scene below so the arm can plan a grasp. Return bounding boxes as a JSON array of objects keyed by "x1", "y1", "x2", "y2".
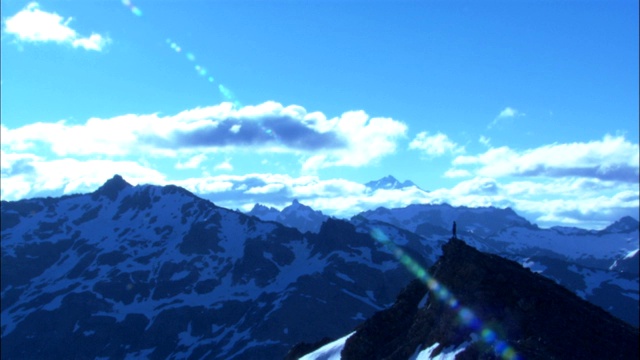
[{"x1": 352, "y1": 204, "x2": 640, "y2": 326}]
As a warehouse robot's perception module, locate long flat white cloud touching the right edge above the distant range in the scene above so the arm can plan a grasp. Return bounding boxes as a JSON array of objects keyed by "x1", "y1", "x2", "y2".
[{"x1": 453, "y1": 135, "x2": 640, "y2": 183}]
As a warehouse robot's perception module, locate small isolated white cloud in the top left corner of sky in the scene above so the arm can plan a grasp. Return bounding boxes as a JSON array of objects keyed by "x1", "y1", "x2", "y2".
[{"x1": 4, "y1": 2, "x2": 111, "y2": 51}]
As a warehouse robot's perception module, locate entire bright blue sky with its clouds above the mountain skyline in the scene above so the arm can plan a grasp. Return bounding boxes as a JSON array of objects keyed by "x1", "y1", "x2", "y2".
[{"x1": 1, "y1": 0, "x2": 639, "y2": 228}]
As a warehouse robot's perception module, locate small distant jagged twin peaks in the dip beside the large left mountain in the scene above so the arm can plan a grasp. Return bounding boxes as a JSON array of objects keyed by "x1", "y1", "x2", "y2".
[{"x1": 247, "y1": 199, "x2": 328, "y2": 233}]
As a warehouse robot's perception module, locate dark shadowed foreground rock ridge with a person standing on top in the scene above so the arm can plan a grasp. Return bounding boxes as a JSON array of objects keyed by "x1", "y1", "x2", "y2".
[{"x1": 332, "y1": 239, "x2": 639, "y2": 360}]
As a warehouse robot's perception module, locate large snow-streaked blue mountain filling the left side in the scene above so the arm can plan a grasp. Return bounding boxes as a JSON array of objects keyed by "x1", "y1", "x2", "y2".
[{"x1": 1, "y1": 176, "x2": 429, "y2": 359}]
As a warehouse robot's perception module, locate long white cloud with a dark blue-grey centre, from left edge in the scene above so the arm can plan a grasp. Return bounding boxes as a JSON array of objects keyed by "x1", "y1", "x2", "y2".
[{"x1": 2, "y1": 101, "x2": 407, "y2": 170}]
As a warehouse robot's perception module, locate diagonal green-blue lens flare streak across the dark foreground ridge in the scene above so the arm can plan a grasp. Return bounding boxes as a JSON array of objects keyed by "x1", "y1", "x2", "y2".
[{"x1": 371, "y1": 229, "x2": 521, "y2": 360}]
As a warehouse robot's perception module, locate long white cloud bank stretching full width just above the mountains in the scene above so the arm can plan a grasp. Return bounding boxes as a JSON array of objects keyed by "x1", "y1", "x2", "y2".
[{"x1": 0, "y1": 102, "x2": 640, "y2": 228}]
